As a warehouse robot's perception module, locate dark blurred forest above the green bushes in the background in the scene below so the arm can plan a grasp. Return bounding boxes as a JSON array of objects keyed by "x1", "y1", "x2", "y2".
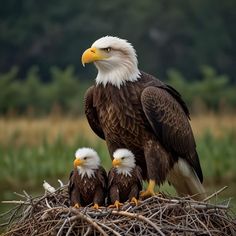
[{"x1": 0, "y1": 0, "x2": 236, "y2": 82}]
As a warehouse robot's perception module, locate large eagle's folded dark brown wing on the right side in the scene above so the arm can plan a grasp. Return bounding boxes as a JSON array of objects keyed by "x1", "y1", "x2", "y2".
[{"x1": 141, "y1": 86, "x2": 203, "y2": 182}]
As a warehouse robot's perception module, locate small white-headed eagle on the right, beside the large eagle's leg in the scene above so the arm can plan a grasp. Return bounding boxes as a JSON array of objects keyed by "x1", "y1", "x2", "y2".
[{"x1": 108, "y1": 148, "x2": 142, "y2": 208}]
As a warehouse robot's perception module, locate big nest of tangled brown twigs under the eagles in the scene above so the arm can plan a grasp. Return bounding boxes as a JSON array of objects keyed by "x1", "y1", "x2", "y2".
[{"x1": 1, "y1": 183, "x2": 236, "y2": 236}]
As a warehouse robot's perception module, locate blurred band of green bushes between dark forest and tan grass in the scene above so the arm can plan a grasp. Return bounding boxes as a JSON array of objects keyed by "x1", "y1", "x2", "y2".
[{"x1": 0, "y1": 66, "x2": 236, "y2": 117}]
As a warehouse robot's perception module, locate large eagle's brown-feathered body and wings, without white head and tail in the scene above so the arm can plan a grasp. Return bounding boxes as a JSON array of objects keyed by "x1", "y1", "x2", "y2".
[{"x1": 85, "y1": 73, "x2": 203, "y2": 184}]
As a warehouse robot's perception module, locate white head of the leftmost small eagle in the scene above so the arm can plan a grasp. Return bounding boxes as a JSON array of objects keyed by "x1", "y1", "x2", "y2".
[{"x1": 74, "y1": 147, "x2": 100, "y2": 178}]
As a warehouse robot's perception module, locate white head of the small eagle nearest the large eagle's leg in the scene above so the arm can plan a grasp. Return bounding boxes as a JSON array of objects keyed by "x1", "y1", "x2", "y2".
[{"x1": 112, "y1": 148, "x2": 135, "y2": 176}]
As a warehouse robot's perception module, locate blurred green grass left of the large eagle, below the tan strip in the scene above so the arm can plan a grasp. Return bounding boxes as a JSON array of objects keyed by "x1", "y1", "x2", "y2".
[{"x1": 0, "y1": 136, "x2": 110, "y2": 193}]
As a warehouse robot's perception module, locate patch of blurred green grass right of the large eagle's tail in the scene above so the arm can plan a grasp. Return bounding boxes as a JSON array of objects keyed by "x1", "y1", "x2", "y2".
[{"x1": 197, "y1": 130, "x2": 236, "y2": 184}]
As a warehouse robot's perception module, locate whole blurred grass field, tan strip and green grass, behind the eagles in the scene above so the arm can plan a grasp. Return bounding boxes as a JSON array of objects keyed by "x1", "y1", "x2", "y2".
[{"x1": 0, "y1": 115, "x2": 236, "y2": 216}]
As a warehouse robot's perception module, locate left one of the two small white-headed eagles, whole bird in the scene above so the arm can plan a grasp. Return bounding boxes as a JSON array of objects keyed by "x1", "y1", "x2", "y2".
[{"x1": 68, "y1": 148, "x2": 107, "y2": 209}]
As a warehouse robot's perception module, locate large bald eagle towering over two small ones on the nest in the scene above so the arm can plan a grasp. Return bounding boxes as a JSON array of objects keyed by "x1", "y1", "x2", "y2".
[{"x1": 82, "y1": 36, "x2": 205, "y2": 199}]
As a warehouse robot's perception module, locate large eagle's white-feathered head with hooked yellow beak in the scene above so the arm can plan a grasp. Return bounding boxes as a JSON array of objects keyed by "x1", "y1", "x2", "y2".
[{"x1": 82, "y1": 36, "x2": 140, "y2": 88}]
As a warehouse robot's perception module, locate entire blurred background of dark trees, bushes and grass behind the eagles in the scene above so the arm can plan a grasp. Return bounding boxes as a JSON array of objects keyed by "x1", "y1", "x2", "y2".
[{"x1": 0, "y1": 0, "x2": 236, "y2": 225}]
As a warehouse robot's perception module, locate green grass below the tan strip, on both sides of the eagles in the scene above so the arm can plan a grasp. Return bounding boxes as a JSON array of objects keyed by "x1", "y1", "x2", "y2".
[{"x1": 0, "y1": 131, "x2": 236, "y2": 217}]
